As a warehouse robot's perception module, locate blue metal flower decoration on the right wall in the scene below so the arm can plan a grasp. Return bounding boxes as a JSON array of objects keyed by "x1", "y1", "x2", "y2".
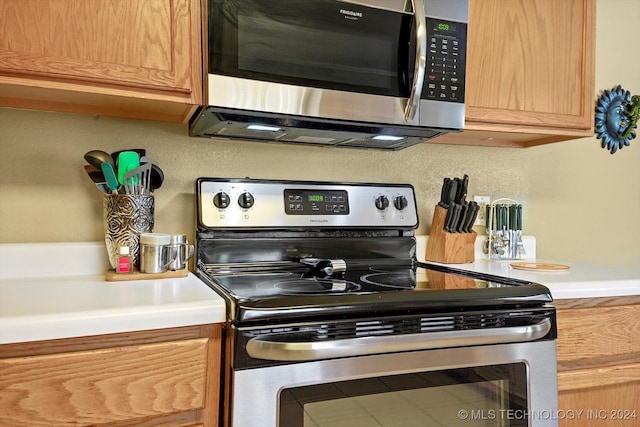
[{"x1": 595, "y1": 85, "x2": 640, "y2": 154}]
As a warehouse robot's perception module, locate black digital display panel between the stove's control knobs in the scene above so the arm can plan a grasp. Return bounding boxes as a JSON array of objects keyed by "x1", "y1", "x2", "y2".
[{"x1": 284, "y1": 189, "x2": 349, "y2": 215}]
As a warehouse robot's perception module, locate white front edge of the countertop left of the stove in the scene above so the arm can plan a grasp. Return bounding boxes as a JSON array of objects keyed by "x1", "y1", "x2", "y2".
[{"x1": 0, "y1": 301, "x2": 225, "y2": 344}]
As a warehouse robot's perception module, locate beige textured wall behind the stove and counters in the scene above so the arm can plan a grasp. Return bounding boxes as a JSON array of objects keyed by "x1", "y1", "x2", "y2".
[{"x1": 0, "y1": 0, "x2": 640, "y2": 269}]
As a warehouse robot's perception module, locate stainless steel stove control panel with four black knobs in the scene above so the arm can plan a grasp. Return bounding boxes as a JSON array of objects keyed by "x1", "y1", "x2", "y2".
[{"x1": 196, "y1": 178, "x2": 418, "y2": 229}]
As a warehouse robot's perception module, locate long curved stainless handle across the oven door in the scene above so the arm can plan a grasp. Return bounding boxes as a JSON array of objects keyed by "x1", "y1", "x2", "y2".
[{"x1": 247, "y1": 318, "x2": 551, "y2": 362}]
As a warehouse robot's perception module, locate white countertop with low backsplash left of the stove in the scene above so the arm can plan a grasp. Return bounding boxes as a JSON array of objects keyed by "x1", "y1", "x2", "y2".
[{"x1": 0, "y1": 242, "x2": 225, "y2": 344}]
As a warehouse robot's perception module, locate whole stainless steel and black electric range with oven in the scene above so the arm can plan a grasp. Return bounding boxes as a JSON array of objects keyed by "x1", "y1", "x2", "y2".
[{"x1": 196, "y1": 178, "x2": 557, "y2": 427}]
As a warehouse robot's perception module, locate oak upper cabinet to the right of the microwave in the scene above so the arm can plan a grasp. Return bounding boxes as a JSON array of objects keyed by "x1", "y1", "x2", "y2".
[{"x1": 434, "y1": 0, "x2": 595, "y2": 146}]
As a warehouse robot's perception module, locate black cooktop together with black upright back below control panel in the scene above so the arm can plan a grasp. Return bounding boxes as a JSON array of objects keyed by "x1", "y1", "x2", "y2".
[{"x1": 196, "y1": 237, "x2": 552, "y2": 323}]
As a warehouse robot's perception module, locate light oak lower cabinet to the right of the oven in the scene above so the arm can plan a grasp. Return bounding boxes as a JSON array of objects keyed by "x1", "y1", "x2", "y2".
[{"x1": 556, "y1": 297, "x2": 640, "y2": 427}]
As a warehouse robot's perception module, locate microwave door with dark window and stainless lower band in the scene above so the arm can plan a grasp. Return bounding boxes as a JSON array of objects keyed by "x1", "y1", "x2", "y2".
[{"x1": 209, "y1": 0, "x2": 426, "y2": 125}]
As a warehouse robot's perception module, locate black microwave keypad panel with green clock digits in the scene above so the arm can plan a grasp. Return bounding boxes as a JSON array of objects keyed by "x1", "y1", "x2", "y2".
[{"x1": 421, "y1": 17, "x2": 467, "y2": 103}]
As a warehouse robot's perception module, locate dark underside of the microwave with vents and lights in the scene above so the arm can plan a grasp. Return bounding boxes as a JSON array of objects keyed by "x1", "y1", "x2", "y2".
[{"x1": 191, "y1": 109, "x2": 446, "y2": 150}]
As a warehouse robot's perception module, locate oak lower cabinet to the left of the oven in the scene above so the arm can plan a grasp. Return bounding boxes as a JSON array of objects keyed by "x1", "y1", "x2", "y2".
[{"x1": 0, "y1": 325, "x2": 221, "y2": 427}]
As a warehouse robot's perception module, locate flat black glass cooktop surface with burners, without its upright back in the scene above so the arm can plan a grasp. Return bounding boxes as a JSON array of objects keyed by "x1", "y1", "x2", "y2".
[{"x1": 199, "y1": 266, "x2": 552, "y2": 323}]
